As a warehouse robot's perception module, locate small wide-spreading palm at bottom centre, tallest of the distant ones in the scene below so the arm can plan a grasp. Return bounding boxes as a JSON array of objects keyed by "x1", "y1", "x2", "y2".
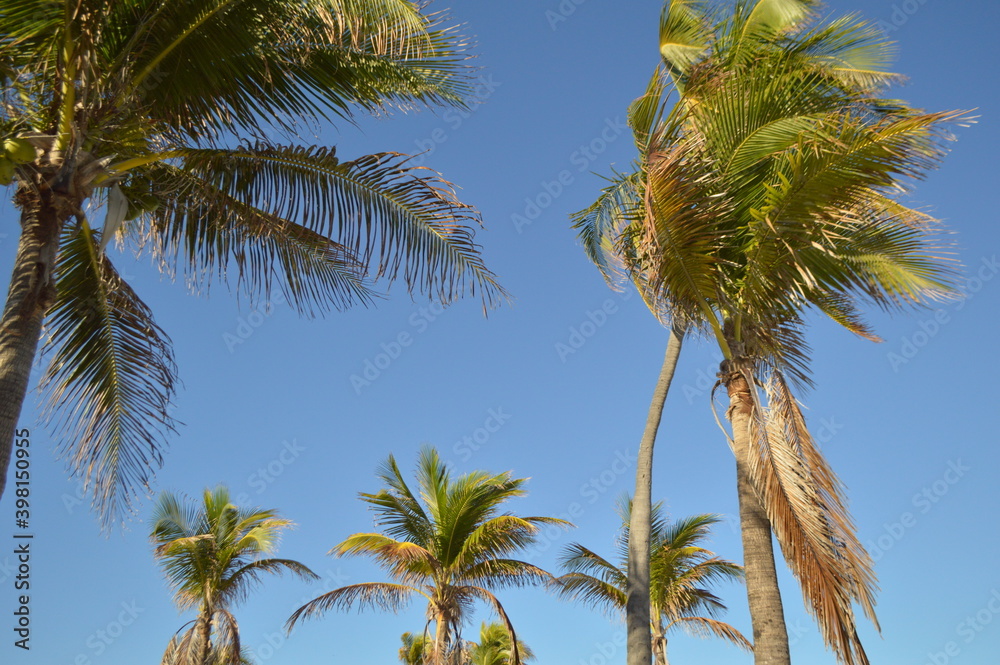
[{"x1": 287, "y1": 447, "x2": 569, "y2": 665}]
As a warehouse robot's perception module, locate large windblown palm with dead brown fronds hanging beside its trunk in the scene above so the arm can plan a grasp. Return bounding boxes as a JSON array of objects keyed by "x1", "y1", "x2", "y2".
[{"x1": 578, "y1": 0, "x2": 958, "y2": 665}]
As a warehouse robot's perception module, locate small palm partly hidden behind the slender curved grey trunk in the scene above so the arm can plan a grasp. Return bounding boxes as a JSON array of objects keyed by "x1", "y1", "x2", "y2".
[{"x1": 552, "y1": 500, "x2": 752, "y2": 665}]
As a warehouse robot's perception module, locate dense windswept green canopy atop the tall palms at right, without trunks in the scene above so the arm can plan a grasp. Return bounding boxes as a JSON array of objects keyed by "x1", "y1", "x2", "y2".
[{"x1": 574, "y1": 0, "x2": 957, "y2": 382}]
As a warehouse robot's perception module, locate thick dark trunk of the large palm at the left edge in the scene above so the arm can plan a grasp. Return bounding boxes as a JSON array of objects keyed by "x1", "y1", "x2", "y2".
[{"x1": 0, "y1": 186, "x2": 65, "y2": 497}]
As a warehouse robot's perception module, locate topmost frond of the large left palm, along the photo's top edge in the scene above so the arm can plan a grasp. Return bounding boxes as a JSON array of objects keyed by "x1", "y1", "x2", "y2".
[{"x1": 115, "y1": 0, "x2": 471, "y2": 138}]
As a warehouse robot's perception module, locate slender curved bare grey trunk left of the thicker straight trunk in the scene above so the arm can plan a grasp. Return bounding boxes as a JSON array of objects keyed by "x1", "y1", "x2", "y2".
[{"x1": 625, "y1": 330, "x2": 684, "y2": 665}]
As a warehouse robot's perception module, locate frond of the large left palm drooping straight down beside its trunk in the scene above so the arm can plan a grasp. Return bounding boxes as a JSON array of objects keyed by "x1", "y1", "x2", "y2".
[{"x1": 42, "y1": 220, "x2": 176, "y2": 520}]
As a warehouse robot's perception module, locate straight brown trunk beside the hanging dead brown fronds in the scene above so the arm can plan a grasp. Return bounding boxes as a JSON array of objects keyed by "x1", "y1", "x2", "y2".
[{"x1": 722, "y1": 363, "x2": 791, "y2": 665}]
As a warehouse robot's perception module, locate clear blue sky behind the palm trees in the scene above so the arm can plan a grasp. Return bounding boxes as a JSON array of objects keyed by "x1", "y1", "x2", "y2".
[{"x1": 0, "y1": 0, "x2": 1000, "y2": 665}]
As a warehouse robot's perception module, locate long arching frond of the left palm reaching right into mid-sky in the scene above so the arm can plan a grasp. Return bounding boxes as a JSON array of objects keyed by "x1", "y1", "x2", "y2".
[{"x1": 157, "y1": 144, "x2": 505, "y2": 307}]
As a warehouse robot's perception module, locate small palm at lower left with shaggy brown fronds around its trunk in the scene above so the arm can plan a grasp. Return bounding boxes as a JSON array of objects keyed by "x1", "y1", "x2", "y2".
[{"x1": 150, "y1": 487, "x2": 317, "y2": 665}]
